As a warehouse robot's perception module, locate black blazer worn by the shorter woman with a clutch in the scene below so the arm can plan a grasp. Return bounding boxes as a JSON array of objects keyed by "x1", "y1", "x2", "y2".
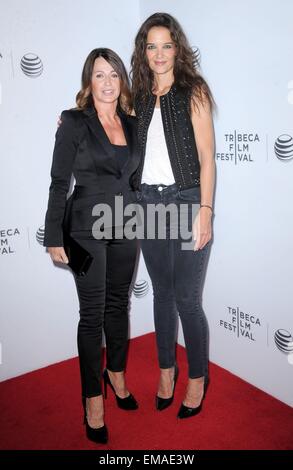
[{"x1": 44, "y1": 107, "x2": 140, "y2": 247}]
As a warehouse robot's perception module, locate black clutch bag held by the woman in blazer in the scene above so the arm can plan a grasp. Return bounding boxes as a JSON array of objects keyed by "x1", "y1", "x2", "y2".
[{"x1": 63, "y1": 232, "x2": 93, "y2": 276}]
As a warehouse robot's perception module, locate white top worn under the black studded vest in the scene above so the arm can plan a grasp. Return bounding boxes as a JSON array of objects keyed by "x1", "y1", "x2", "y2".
[{"x1": 141, "y1": 108, "x2": 175, "y2": 185}]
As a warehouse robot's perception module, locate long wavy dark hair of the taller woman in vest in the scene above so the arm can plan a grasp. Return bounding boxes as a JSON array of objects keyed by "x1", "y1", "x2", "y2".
[{"x1": 130, "y1": 13, "x2": 215, "y2": 109}]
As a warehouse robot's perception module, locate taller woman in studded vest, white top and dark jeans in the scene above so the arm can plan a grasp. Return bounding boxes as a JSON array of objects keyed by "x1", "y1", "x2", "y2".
[{"x1": 131, "y1": 13, "x2": 215, "y2": 418}]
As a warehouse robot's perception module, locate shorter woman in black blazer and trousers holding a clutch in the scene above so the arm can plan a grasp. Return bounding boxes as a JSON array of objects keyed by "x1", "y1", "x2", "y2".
[{"x1": 44, "y1": 48, "x2": 139, "y2": 443}]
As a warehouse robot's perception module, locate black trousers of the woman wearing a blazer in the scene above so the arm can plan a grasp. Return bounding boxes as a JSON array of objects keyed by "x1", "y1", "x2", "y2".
[{"x1": 72, "y1": 233, "x2": 137, "y2": 398}]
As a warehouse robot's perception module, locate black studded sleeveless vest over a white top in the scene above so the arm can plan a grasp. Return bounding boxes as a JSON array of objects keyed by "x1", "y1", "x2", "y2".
[{"x1": 134, "y1": 85, "x2": 200, "y2": 189}]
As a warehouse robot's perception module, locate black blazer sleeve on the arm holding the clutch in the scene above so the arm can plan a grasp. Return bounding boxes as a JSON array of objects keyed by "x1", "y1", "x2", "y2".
[{"x1": 44, "y1": 111, "x2": 78, "y2": 247}]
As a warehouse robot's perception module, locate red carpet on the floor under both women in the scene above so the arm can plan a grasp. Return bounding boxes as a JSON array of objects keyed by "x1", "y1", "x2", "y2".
[{"x1": 0, "y1": 334, "x2": 293, "y2": 450}]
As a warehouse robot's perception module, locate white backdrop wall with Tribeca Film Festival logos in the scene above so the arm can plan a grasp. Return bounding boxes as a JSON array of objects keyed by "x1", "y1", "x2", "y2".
[{"x1": 0, "y1": 0, "x2": 293, "y2": 406}]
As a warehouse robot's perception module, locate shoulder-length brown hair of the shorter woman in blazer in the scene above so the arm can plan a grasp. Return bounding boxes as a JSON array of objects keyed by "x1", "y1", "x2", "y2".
[{"x1": 76, "y1": 47, "x2": 132, "y2": 113}]
